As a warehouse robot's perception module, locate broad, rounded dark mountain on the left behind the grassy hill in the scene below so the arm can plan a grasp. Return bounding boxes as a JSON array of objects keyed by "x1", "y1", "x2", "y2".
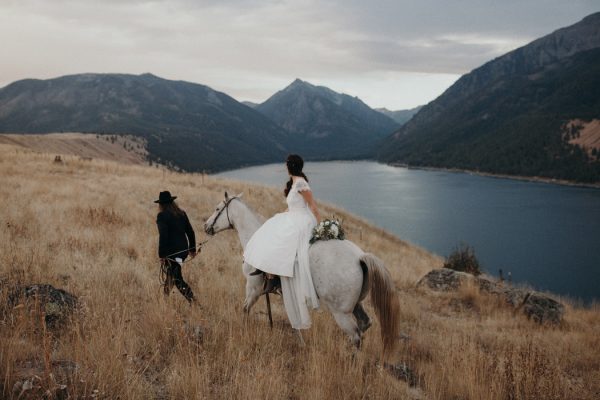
[{"x1": 0, "y1": 74, "x2": 290, "y2": 171}]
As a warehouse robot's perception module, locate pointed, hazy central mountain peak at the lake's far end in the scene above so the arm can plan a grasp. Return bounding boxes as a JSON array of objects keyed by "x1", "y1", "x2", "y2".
[{"x1": 256, "y1": 79, "x2": 398, "y2": 159}]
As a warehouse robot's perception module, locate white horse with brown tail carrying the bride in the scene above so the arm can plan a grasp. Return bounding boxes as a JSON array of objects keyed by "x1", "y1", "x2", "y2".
[{"x1": 204, "y1": 192, "x2": 399, "y2": 351}]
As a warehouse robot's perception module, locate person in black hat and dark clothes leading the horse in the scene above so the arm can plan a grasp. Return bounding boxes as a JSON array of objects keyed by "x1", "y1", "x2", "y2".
[{"x1": 154, "y1": 191, "x2": 196, "y2": 303}]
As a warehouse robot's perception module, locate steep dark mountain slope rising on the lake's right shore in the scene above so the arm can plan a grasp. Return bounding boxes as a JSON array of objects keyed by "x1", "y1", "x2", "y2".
[{"x1": 378, "y1": 13, "x2": 600, "y2": 182}]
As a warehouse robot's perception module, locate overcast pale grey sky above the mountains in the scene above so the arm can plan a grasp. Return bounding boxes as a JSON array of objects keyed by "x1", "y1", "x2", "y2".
[{"x1": 0, "y1": 0, "x2": 600, "y2": 109}]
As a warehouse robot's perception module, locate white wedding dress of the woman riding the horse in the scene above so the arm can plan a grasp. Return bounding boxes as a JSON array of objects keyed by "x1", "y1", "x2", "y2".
[{"x1": 244, "y1": 177, "x2": 319, "y2": 329}]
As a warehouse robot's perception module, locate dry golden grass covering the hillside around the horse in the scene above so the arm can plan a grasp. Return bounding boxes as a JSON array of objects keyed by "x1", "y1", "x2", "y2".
[{"x1": 0, "y1": 145, "x2": 600, "y2": 399}]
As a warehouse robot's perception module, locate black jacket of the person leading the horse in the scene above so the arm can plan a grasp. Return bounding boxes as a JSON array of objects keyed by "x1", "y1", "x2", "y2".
[{"x1": 156, "y1": 211, "x2": 196, "y2": 259}]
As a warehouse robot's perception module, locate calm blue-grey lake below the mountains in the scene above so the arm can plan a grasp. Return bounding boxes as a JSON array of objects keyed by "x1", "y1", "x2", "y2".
[{"x1": 217, "y1": 161, "x2": 600, "y2": 303}]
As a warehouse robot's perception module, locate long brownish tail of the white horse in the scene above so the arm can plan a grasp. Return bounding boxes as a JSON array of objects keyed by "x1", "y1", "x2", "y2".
[{"x1": 360, "y1": 253, "x2": 400, "y2": 352}]
